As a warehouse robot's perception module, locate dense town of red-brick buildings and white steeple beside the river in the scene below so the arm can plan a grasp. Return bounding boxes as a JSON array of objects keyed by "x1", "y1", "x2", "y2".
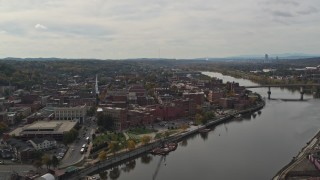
[{"x1": 0, "y1": 59, "x2": 260, "y2": 178}]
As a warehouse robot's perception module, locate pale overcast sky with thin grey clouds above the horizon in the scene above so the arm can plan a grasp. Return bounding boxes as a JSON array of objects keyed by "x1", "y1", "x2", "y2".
[{"x1": 0, "y1": 0, "x2": 320, "y2": 59}]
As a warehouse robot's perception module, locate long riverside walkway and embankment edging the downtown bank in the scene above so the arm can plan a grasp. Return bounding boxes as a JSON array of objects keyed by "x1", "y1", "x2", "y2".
[{"x1": 63, "y1": 101, "x2": 265, "y2": 180}]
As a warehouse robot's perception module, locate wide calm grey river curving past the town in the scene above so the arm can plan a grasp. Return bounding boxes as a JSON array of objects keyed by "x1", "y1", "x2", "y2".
[{"x1": 94, "y1": 72, "x2": 320, "y2": 180}]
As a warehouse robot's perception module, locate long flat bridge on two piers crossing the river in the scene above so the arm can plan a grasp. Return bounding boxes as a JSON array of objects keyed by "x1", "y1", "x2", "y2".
[{"x1": 245, "y1": 84, "x2": 320, "y2": 101}]
